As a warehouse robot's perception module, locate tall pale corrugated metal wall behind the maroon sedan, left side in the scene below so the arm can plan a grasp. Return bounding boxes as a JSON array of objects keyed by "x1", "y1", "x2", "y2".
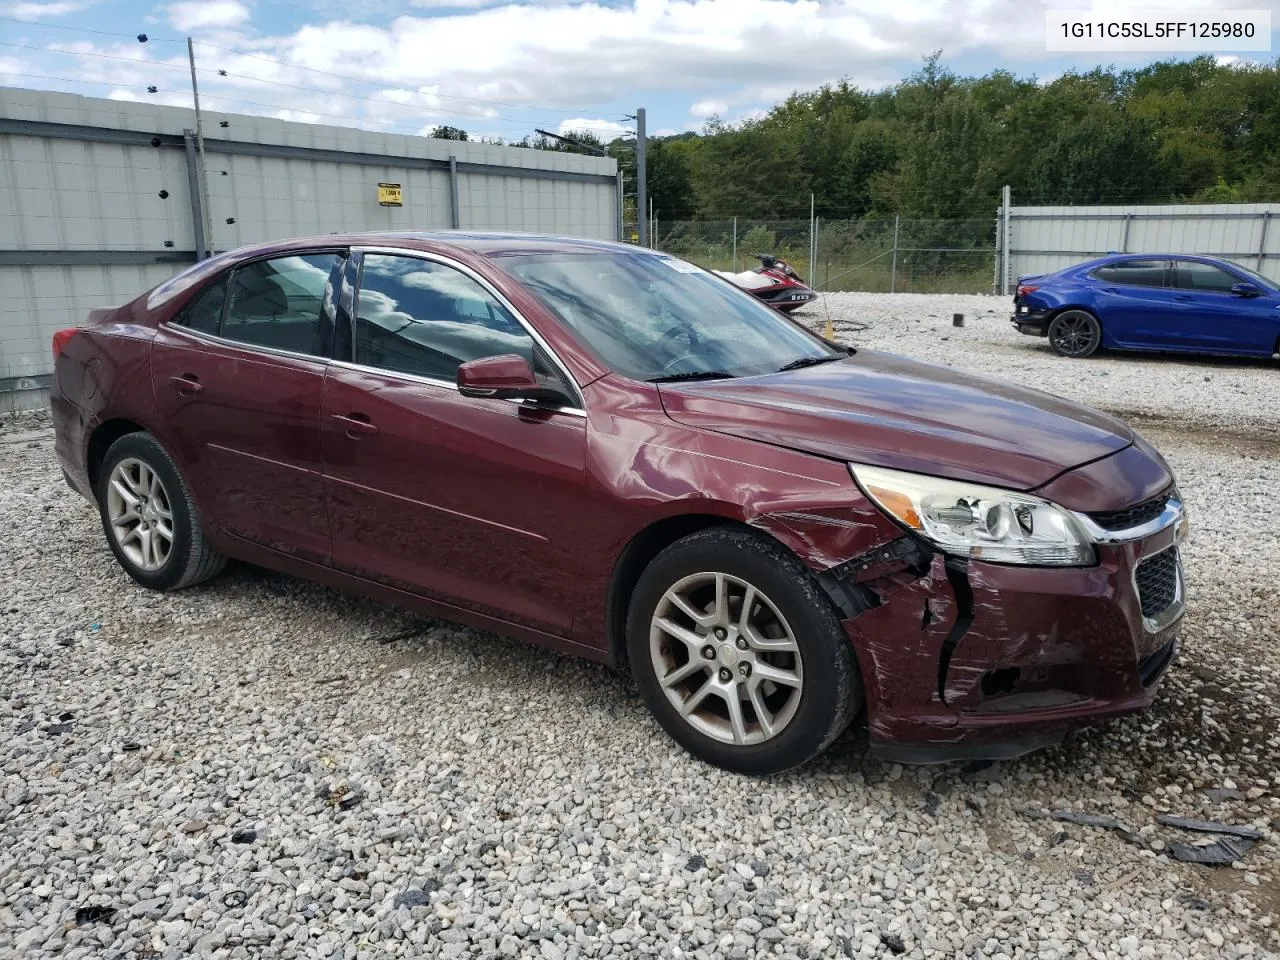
[{"x1": 0, "y1": 81, "x2": 621, "y2": 407}]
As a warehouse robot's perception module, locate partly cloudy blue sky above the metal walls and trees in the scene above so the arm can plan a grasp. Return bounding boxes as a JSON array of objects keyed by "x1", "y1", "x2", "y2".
[{"x1": 0, "y1": 0, "x2": 1280, "y2": 141}]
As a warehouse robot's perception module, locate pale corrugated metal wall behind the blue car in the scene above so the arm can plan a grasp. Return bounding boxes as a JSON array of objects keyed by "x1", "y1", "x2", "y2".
[{"x1": 1009, "y1": 204, "x2": 1280, "y2": 280}]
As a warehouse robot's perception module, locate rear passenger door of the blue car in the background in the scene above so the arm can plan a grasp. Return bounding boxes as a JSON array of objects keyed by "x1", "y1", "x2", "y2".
[{"x1": 1092, "y1": 257, "x2": 1175, "y2": 347}]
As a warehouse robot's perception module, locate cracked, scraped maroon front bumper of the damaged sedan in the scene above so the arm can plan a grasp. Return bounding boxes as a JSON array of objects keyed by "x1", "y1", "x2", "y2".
[{"x1": 836, "y1": 497, "x2": 1185, "y2": 763}]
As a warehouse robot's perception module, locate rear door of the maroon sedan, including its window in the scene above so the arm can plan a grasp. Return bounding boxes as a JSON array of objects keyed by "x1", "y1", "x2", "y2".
[{"x1": 151, "y1": 251, "x2": 343, "y2": 563}]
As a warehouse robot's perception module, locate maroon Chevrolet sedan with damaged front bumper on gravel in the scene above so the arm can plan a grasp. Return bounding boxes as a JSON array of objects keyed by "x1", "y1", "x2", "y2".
[{"x1": 51, "y1": 233, "x2": 1185, "y2": 774}]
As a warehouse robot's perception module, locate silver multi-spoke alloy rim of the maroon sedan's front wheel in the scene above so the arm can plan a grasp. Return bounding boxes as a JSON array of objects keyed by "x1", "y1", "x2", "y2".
[{"x1": 649, "y1": 572, "x2": 804, "y2": 746}]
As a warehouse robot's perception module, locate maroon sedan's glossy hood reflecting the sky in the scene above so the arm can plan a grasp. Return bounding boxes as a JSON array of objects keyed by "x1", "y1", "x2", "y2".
[{"x1": 659, "y1": 349, "x2": 1134, "y2": 490}]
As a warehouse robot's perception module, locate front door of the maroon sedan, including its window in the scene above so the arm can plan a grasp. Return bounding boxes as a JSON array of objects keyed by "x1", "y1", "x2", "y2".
[{"x1": 321, "y1": 252, "x2": 586, "y2": 635}]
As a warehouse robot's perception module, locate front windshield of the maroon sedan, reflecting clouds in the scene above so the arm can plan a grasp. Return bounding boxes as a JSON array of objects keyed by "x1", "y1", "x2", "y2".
[{"x1": 499, "y1": 251, "x2": 847, "y2": 380}]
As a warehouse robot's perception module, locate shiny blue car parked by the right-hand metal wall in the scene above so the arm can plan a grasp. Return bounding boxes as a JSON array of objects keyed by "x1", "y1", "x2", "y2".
[{"x1": 1012, "y1": 253, "x2": 1280, "y2": 358}]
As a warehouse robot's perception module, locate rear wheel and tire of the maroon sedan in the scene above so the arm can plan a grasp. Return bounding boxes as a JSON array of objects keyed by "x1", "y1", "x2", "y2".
[{"x1": 97, "y1": 433, "x2": 227, "y2": 590}]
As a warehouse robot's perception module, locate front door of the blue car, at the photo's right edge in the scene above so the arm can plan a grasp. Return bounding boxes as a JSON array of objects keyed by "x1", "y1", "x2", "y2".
[{"x1": 1174, "y1": 260, "x2": 1280, "y2": 356}]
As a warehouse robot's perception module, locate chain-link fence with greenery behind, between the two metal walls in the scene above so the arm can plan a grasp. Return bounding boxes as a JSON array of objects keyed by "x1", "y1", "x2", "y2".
[{"x1": 652, "y1": 218, "x2": 998, "y2": 293}]
